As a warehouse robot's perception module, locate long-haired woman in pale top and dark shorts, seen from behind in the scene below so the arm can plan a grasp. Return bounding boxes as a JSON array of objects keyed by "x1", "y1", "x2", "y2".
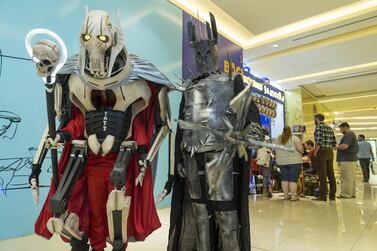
[{"x1": 275, "y1": 126, "x2": 304, "y2": 201}]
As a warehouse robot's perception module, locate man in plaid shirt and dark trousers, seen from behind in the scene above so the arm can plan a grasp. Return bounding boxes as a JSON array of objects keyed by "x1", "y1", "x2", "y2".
[{"x1": 314, "y1": 114, "x2": 336, "y2": 201}]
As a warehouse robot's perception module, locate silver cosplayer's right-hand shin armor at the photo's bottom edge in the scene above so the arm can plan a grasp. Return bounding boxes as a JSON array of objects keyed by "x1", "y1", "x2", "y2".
[{"x1": 215, "y1": 210, "x2": 241, "y2": 251}]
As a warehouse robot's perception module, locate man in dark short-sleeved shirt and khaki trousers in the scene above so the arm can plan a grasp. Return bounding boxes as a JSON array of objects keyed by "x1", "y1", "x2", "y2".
[{"x1": 335, "y1": 122, "x2": 359, "y2": 198}]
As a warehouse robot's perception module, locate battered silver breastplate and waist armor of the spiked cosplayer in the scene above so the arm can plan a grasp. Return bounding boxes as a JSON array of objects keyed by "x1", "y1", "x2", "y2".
[{"x1": 182, "y1": 73, "x2": 234, "y2": 153}]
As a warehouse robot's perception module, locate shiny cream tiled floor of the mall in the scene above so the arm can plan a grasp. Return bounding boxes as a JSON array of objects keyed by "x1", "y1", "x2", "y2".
[{"x1": 0, "y1": 173, "x2": 377, "y2": 251}]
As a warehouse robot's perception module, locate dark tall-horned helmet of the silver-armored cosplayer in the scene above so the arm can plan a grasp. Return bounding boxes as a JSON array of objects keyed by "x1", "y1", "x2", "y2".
[{"x1": 187, "y1": 12, "x2": 218, "y2": 75}]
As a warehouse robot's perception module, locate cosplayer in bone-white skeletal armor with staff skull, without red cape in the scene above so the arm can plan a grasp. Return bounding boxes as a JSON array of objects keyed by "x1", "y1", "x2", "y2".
[{"x1": 29, "y1": 10, "x2": 173, "y2": 251}]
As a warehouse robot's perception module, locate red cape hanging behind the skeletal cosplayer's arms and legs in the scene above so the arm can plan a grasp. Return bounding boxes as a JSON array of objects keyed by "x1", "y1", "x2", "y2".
[{"x1": 34, "y1": 84, "x2": 161, "y2": 241}]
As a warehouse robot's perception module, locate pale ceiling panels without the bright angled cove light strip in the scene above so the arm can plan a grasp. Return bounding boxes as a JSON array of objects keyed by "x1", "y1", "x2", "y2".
[{"x1": 207, "y1": 0, "x2": 377, "y2": 137}]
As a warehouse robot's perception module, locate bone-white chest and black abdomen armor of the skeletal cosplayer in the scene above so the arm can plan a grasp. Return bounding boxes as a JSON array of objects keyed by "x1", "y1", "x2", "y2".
[{"x1": 69, "y1": 74, "x2": 151, "y2": 155}]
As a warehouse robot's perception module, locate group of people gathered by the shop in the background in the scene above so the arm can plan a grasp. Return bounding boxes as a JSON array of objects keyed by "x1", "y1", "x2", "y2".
[{"x1": 250, "y1": 114, "x2": 377, "y2": 201}]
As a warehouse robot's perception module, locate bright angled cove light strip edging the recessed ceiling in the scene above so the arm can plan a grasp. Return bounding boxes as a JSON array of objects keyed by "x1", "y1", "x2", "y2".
[{"x1": 169, "y1": 0, "x2": 377, "y2": 49}]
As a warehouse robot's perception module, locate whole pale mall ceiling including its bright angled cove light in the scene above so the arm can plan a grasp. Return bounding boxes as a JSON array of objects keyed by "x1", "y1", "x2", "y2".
[{"x1": 169, "y1": 0, "x2": 377, "y2": 138}]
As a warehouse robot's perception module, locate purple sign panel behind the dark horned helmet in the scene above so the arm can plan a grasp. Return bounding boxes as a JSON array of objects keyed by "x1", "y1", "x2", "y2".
[{"x1": 182, "y1": 12, "x2": 243, "y2": 79}]
